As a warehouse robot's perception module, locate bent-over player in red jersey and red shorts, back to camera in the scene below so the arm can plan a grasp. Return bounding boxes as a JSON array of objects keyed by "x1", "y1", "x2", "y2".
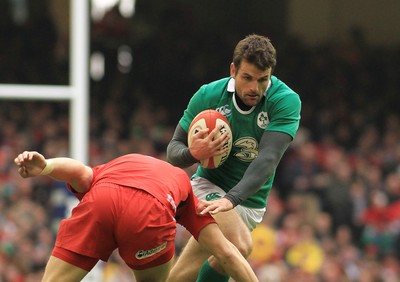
[{"x1": 14, "y1": 151, "x2": 257, "y2": 282}]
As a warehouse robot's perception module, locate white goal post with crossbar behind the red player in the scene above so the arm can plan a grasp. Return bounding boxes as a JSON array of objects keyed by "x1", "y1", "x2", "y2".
[{"x1": 0, "y1": 0, "x2": 90, "y2": 163}]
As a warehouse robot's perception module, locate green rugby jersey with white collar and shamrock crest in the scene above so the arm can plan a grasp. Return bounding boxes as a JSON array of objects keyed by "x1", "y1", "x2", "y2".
[{"x1": 179, "y1": 76, "x2": 301, "y2": 208}]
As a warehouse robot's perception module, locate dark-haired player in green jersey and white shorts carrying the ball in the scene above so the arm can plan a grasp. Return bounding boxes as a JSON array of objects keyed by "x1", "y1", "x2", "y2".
[{"x1": 167, "y1": 34, "x2": 301, "y2": 282}]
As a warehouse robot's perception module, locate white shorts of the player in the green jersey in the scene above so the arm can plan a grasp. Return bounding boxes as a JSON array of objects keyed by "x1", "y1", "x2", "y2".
[{"x1": 191, "y1": 177, "x2": 266, "y2": 231}]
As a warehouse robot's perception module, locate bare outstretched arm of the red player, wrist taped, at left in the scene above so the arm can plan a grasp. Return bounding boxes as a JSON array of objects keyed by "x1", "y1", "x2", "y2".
[{"x1": 14, "y1": 151, "x2": 93, "y2": 193}]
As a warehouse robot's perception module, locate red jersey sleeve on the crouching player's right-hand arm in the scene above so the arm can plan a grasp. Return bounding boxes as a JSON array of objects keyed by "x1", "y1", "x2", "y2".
[{"x1": 175, "y1": 189, "x2": 215, "y2": 240}]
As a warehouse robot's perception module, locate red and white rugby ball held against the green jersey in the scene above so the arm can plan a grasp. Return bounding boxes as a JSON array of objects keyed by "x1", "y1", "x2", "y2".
[{"x1": 188, "y1": 110, "x2": 232, "y2": 169}]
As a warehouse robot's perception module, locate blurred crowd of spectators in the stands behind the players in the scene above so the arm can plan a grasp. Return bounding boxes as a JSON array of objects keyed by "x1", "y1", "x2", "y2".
[{"x1": 0, "y1": 2, "x2": 400, "y2": 282}]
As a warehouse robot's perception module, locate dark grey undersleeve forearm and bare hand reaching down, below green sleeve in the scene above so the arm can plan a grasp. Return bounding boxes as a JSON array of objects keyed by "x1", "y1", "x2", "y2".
[{"x1": 198, "y1": 131, "x2": 293, "y2": 214}]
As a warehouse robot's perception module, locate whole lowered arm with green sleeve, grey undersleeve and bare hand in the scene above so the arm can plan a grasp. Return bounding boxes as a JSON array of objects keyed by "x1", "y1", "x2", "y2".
[{"x1": 198, "y1": 91, "x2": 301, "y2": 214}]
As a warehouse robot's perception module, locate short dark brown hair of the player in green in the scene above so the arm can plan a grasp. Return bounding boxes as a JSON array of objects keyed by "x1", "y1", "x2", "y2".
[{"x1": 233, "y1": 34, "x2": 276, "y2": 70}]
